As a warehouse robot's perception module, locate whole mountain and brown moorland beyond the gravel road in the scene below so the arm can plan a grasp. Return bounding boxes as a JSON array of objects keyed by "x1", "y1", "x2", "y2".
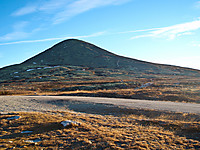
[{"x1": 0, "y1": 39, "x2": 200, "y2": 103}]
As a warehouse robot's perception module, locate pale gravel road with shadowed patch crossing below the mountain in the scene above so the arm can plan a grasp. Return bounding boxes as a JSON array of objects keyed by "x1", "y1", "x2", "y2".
[{"x1": 0, "y1": 96, "x2": 200, "y2": 114}]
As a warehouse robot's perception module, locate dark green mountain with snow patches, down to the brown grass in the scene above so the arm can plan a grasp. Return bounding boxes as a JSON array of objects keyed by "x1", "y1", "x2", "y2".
[{"x1": 0, "y1": 39, "x2": 200, "y2": 81}]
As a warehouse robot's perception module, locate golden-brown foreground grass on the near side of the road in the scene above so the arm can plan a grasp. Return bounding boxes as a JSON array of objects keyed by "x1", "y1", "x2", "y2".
[{"x1": 0, "y1": 110, "x2": 200, "y2": 149}]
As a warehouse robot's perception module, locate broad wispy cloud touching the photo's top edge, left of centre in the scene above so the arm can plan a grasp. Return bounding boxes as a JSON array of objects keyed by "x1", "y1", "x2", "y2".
[{"x1": 12, "y1": 0, "x2": 131, "y2": 24}]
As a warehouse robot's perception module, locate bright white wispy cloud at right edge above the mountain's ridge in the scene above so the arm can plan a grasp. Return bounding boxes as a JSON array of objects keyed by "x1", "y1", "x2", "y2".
[{"x1": 131, "y1": 20, "x2": 200, "y2": 39}]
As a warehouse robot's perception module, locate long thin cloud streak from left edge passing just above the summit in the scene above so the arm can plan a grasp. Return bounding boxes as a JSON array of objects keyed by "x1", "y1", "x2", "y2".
[{"x1": 0, "y1": 32, "x2": 105, "y2": 45}]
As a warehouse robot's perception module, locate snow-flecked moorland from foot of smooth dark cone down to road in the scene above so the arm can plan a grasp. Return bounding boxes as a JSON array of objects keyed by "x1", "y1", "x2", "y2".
[{"x1": 0, "y1": 65, "x2": 200, "y2": 103}]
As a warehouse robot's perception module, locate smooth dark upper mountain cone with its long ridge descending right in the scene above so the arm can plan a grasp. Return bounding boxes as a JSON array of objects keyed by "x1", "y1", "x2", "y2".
[{"x1": 22, "y1": 39, "x2": 200, "y2": 75}]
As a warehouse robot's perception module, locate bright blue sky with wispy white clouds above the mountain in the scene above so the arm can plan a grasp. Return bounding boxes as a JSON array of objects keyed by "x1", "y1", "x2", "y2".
[{"x1": 0, "y1": 0, "x2": 200, "y2": 69}]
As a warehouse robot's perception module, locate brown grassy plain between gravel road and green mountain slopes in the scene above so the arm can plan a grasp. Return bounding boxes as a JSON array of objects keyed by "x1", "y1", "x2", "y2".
[{"x1": 0, "y1": 77, "x2": 200, "y2": 103}]
